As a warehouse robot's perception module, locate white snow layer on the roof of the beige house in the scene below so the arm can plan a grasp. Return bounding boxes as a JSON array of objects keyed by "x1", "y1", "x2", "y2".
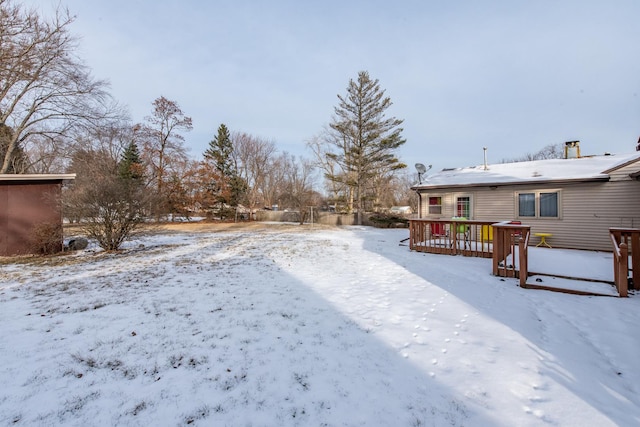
[{"x1": 414, "y1": 152, "x2": 640, "y2": 188}]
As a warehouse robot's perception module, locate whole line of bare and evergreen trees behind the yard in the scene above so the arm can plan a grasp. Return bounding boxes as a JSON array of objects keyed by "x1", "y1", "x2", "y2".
[{"x1": 0, "y1": 0, "x2": 418, "y2": 249}]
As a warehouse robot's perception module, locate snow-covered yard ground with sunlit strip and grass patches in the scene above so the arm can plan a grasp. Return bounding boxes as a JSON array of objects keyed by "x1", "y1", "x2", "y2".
[{"x1": 0, "y1": 225, "x2": 640, "y2": 426}]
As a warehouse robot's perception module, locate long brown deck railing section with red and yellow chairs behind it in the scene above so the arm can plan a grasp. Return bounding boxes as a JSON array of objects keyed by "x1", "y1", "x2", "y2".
[{"x1": 409, "y1": 218, "x2": 496, "y2": 258}]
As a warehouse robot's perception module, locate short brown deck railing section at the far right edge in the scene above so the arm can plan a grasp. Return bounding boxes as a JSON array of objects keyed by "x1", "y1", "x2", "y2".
[{"x1": 609, "y1": 227, "x2": 640, "y2": 297}]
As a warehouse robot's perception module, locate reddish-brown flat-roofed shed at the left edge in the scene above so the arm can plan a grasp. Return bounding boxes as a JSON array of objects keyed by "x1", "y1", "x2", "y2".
[{"x1": 0, "y1": 174, "x2": 75, "y2": 256}]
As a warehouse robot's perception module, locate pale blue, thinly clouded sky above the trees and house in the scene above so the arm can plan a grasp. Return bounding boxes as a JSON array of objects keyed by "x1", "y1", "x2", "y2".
[{"x1": 21, "y1": 0, "x2": 640, "y2": 175}]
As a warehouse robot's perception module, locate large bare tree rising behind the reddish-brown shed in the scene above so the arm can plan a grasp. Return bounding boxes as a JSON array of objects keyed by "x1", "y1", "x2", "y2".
[{"x1": 0, "y1": 0, "x2": 109, "y2": 173}]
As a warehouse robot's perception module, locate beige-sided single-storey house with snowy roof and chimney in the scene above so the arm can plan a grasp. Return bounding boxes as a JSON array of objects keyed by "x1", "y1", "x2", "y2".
[{"x1": 412, "y1": 141, "x2": 640, "y2": 251}]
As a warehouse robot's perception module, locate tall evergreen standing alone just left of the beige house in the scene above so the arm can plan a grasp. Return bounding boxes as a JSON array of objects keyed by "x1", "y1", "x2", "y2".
[{"x1": 326, "y1": 71, "x2": 406, "y2": 224}]
